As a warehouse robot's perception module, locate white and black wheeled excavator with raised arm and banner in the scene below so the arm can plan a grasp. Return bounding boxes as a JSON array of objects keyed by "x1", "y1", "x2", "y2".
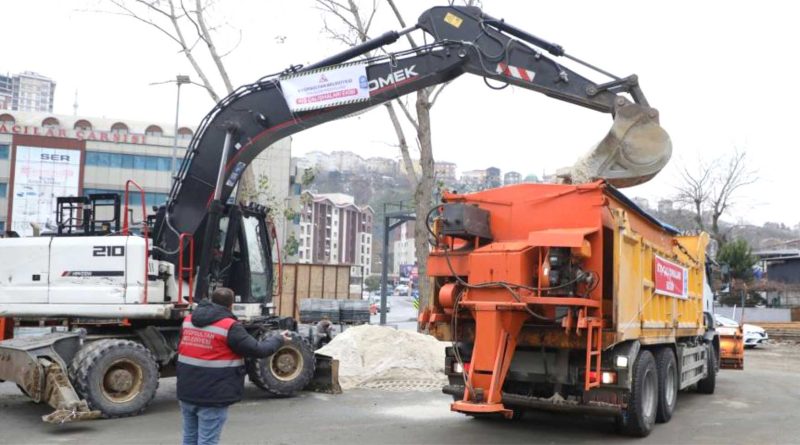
[{"x1": 0, "y1": 6, "x2": 671, "y2": 423}]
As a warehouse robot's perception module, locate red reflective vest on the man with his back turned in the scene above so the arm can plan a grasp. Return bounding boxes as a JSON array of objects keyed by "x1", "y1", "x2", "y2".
[{"x1": 178, "y1": 315, "x2": 244, "y2": 368}]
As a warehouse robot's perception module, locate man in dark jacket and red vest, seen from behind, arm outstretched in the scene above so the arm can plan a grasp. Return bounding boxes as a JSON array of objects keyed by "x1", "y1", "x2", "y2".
[{"x1": 177, "y1": 287, "x2": 291, "y2": 445}]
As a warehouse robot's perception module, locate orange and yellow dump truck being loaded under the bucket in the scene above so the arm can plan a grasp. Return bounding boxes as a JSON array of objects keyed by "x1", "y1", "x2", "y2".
[{"x1": 420, "y1": 182, "x2": 719, "y2": 436}]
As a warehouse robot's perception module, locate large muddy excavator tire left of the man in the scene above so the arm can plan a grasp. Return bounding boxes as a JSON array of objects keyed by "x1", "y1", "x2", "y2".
[{"x1": 69, "y1": 339, "x2": 159, "y2": 418}]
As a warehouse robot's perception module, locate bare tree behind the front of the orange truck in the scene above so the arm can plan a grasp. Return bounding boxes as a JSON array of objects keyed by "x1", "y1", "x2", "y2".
[{"x1": 676, "y1": 149, "x2": 758, "y2": 246}]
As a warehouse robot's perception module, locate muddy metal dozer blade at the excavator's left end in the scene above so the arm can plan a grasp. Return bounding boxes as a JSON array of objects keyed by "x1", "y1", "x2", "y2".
[{"x1": 0, "y1": 333, "x2": 100, "y2": 424}]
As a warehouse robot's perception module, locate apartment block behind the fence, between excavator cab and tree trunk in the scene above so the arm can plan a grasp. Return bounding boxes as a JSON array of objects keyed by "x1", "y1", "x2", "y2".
[{"x1": 290, "y1": 190, "x2": 375, "y2": 277}]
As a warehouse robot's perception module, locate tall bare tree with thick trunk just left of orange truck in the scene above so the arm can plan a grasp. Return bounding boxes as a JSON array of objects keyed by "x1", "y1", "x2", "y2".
[{"x1": 316, "y1": 0, "x2": 477, "y2": 310}]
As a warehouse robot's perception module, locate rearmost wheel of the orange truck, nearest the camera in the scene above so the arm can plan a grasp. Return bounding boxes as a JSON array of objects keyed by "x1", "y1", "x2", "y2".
[{"x1": 617, "y1": 350, "x2": 658, "y2": 437}]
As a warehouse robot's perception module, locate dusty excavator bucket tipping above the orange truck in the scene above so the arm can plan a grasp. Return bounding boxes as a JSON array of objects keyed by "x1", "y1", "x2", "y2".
[{"x1": 558, "y1": 99, "x2": 672, "y2": 188}]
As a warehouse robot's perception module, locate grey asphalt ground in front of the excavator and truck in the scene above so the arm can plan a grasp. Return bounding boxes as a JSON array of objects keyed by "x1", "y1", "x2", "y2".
[{"x1": 0, "y1": 346, "x2": 800, "y2": 445}]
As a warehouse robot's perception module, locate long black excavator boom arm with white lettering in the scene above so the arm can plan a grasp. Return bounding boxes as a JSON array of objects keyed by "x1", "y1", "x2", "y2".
[{"x1": 155, "y1": 6, "x2": 668, "y2": 250}]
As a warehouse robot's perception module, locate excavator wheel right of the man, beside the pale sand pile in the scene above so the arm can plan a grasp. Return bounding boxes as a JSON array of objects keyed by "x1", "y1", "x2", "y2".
[{"x1": 246, "y1": 331, "x2": 314, "y2": 397}]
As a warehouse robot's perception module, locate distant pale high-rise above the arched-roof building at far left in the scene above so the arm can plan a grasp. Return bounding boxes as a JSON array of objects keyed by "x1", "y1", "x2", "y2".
[{"x1": 0, "y1": 71, "x2": 56, "y2": 113}]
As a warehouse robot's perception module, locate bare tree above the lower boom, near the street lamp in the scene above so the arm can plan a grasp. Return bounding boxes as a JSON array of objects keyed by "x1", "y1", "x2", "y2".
[{"x1": 101, "y1": 0, "x2": 257, "y2": 201}]
